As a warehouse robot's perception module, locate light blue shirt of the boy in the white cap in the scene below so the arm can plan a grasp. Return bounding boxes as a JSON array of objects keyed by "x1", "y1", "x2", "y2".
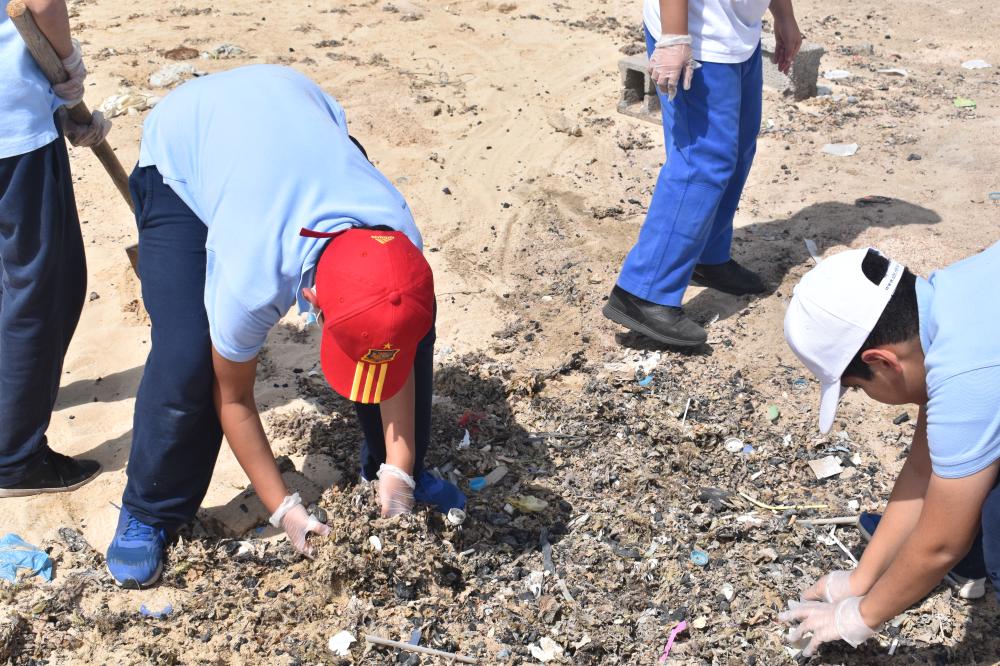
[{"x1": 917, "y1": 243, "x2": 1000, "y2": 478}]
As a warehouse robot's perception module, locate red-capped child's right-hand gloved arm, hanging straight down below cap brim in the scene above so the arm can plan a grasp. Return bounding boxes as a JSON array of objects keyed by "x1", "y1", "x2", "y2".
[{"x1": 379, "y1": 371, "x2": 416, "y2": 516}]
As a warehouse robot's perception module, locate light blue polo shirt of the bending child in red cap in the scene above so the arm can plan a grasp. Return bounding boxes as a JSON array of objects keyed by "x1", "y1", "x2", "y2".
[{"x1": 139, "y1": 65, "x2": 422, "y2": 361}]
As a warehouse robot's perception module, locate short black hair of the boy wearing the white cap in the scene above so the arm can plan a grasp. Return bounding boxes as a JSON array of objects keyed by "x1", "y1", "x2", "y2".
[{"x1": 842, "y1": 249, "x2": 920, "y2": 379}]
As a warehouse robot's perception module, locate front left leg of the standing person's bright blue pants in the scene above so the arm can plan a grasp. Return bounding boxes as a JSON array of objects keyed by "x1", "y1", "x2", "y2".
[{"x1": 618, "y1": 31, "x2": 743, "y2": 306}]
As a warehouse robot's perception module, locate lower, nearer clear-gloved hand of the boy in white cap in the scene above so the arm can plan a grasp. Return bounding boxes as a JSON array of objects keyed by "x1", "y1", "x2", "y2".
[{"x1": 778, "y1": 597, "x2": 877, "y2": 657}]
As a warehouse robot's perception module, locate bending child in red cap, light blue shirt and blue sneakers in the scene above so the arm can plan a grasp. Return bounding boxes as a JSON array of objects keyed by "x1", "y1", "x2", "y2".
[{"x1": 107, "y1": 65, "x2": 465, "y2": 587}]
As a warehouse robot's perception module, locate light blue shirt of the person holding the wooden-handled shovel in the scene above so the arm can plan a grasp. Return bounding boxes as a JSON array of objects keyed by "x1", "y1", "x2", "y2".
[{"x1": 0, "y1": 0, "x2": 63, "y2": 159}]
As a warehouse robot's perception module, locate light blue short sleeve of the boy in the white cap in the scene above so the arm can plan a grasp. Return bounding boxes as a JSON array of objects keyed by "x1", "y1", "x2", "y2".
[{"x1": 927, "y1": 365, "x2": 1000, "y2": 478}]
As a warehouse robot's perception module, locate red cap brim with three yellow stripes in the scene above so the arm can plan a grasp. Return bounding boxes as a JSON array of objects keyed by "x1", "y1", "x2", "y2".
[{"x1": 320, "y1": 329, "x2": 417, "y2": 405}]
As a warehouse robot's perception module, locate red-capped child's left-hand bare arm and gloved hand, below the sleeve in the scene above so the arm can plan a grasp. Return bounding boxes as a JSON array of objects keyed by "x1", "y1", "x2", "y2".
[{"x1": 212, "y1": 347, "x2": 329, "y2": 555}]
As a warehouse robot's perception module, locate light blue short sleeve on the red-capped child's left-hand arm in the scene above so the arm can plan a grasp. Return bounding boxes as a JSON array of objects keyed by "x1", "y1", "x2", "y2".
[{"x1": 205, "y1": 252, "x2": 281, "y2": 363}]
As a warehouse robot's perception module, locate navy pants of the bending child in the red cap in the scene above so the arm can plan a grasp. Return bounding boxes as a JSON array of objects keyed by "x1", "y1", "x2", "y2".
[{"x1": 122, "y1": 166, "x2": 434, "y2": 531}]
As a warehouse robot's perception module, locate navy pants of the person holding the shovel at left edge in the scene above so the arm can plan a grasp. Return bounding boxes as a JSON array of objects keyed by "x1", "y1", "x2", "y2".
[{"x1": 0, "y1": 124, "x2": 87, "y2": 485}]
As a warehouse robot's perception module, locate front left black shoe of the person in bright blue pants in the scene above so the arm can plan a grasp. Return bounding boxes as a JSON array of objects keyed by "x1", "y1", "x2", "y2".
[{"x1": 602, "y1": 285, "x2": 708, "y2": 347}]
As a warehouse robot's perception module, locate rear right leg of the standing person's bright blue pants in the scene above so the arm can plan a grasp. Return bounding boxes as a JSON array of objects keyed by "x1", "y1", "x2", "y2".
[{"x1": 698, "y1": 44, "x2": 764, "y2": 264}]
